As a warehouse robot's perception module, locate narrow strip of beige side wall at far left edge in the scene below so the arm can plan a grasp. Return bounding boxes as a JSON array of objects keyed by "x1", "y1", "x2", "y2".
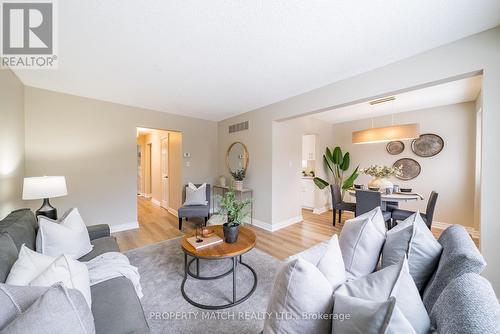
[{"x1": 0, "y1": 68, "x2": 24, "y2": 219}]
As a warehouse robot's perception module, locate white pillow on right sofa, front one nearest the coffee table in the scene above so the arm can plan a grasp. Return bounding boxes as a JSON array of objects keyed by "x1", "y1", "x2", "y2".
[{"x1": 264, "y1": 257, "x2": 333, "y2": 334}]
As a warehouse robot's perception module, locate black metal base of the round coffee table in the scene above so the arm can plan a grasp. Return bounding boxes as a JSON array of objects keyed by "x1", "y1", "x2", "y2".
[{"x1": 181, "y1": 253, "x2": 257, "y2": 310}]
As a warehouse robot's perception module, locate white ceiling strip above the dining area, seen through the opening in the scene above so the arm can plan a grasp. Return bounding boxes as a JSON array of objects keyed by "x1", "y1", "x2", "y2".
[{"x1": 312, "y1": 75, "x2": 482, "y2": 124}]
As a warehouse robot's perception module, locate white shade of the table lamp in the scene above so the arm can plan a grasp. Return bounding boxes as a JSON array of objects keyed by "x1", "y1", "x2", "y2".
[{"x1": 23, "y1": 176, "x2": 68, "y2": 200}]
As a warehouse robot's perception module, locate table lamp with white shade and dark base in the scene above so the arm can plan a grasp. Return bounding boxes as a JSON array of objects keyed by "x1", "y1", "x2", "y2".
[{"x1": 23, "y1": 176, "x2": 68, "y2": 220}]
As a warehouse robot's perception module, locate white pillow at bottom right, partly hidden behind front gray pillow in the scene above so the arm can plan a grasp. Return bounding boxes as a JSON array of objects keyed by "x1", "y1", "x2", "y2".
[{"x1": 335, "y1": 258, "x2": 430, "y2": 334}]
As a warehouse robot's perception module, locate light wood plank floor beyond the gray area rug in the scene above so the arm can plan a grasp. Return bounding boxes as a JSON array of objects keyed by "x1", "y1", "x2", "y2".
[{"x1": 113, "y1": 197, "x2": 478, "y2": 260}]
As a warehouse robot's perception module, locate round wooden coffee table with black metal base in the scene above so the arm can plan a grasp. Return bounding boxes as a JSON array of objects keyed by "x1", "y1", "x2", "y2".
[{"x1": 181, "y1": 225, "x2": 257, "y2": 310}]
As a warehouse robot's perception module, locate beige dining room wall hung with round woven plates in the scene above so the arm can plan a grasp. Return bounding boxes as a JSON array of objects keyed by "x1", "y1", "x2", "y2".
[{"x1": 333, "y1": 102, "x2": 476, "y2": 227}]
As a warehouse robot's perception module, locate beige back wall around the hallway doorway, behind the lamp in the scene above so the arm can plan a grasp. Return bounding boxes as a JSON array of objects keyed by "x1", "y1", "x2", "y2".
[{"x1": 25, "y1": 87, "x2": 217, "y2": 230}]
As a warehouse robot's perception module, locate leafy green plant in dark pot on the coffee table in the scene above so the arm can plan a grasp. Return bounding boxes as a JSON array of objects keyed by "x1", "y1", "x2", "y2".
[{"x1": 219, "y1": 188, "x2": 251, "y2": 243}]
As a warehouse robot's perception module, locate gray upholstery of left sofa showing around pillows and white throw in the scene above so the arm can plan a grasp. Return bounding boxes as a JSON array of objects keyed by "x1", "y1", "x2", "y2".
[{"x1": 0, "y1": 209, "x2": 149, "y2": 334}]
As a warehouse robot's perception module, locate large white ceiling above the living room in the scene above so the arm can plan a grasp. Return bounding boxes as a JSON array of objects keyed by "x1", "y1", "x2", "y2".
[{"x1": 11, "y1": 0, "x2": 500, "y2": 120}]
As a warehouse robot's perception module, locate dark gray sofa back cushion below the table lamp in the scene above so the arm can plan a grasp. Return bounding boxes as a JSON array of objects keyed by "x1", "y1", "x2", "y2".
[{"x1": 0, "y1": 209, "x2": 38, "y2": 250}]
